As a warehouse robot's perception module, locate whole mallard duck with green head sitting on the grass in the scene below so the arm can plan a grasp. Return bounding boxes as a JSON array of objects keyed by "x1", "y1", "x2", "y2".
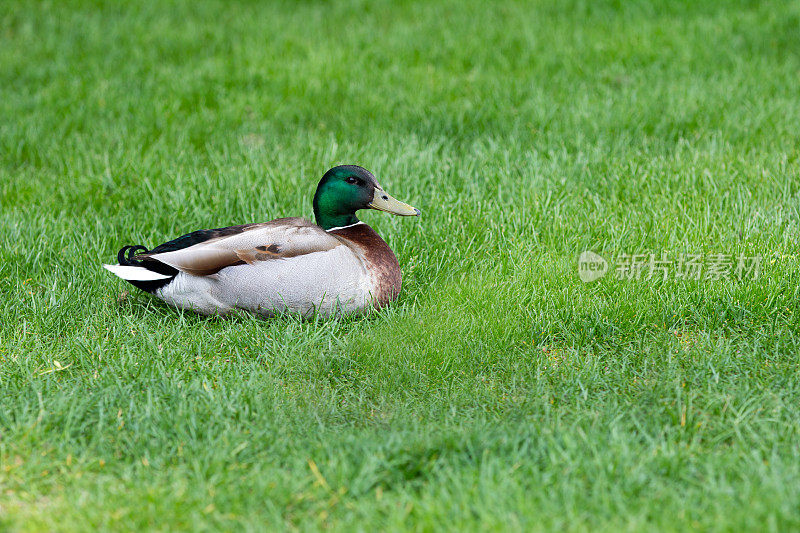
[{"x1": 103, "y1": 165, "x2": 420, "y2": 317}]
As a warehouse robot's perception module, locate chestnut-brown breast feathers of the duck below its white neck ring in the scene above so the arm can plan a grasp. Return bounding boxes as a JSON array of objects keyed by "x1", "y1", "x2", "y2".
[{"x1": 329, "y1": 222, "x2": 402, "y2": 306}]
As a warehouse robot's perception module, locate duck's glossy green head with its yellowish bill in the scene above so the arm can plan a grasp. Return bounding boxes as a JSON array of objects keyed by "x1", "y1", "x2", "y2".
[{"x1": 314, "y1": 165, "x2": 419, "y2": 230}]
